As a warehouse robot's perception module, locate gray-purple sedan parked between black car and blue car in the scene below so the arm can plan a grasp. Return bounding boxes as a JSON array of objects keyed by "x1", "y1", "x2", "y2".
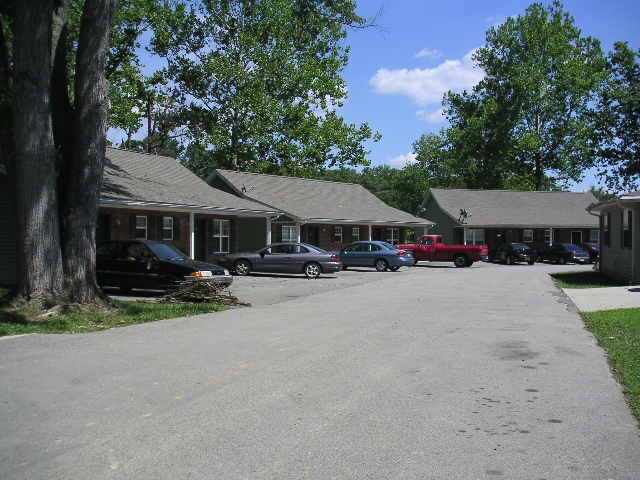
[{"x1": 219, "y1": 242, "x2": 342, "y2": 278}]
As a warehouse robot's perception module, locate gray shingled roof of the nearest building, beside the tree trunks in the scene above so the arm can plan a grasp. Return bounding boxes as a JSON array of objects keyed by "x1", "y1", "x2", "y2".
[{"x1": 100, "y1": 148, "x2": 276, "y2": 215}]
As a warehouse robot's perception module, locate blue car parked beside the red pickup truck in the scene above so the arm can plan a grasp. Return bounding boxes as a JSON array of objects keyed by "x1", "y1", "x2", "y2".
[{"x1": 340, "y1": 241, "x2": 414, "y2": 272}]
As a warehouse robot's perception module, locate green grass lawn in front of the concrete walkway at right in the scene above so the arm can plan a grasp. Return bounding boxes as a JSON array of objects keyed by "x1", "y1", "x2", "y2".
[{"x1": 582, "y1": 308, "x2": 640, "y2": 421}]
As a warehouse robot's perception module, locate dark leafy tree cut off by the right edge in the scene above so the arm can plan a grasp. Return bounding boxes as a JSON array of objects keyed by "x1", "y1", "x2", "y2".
[{"x1": 595, "y1": 42, "x2": 640, "y2": 192}]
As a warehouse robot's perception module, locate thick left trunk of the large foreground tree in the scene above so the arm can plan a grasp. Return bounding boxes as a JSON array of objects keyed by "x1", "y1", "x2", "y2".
[{"x1": 13, "y1": 0, "x2": 63, "y2": 304}]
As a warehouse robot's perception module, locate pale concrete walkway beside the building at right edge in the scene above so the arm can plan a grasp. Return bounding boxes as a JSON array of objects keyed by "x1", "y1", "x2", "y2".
[{"x1": 563, "y1": 285, "x2": 640, "y2": 312}]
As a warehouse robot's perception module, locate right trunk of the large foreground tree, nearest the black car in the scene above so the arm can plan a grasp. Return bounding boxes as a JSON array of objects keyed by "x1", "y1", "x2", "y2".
[{"x1": 64, "y1": 0, "x2": 116, "y2": 303}]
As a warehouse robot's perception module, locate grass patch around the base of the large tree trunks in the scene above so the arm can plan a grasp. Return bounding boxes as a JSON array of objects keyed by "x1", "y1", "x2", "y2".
[{"x1": 0, "y1": 290, "x2": 225, "y2": 336}]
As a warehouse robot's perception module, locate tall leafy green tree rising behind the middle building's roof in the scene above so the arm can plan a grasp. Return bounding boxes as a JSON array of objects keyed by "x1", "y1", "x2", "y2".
[{"x1": 152, "y1": 0, "x2": 378, "y2": 174}]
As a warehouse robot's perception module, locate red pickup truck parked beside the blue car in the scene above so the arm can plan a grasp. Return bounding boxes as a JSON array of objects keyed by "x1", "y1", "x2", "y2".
[{"x1": 396, "y1": 235, "x2": 489, "y2": 267}]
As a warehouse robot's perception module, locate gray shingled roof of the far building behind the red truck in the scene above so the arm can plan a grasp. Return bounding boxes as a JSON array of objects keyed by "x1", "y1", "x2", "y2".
[{"x1": 431, "y1": 188, "x2": 598, "y2": 228}]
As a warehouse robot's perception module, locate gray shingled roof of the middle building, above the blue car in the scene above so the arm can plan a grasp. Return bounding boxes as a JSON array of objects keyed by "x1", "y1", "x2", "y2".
[{"x1": 217, "y1": 170, "x2": 433, "y2": 226}]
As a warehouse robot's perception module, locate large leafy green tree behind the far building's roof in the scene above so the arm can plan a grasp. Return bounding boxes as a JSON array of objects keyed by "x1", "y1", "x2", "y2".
[{"x1": 418, "y1": 1, "x2": 607, "y2": 190}]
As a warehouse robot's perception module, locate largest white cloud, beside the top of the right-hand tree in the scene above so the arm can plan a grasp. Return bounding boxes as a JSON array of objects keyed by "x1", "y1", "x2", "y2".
[{"x1": 369, "y1": 50, "x2": 484, "y2": 106}]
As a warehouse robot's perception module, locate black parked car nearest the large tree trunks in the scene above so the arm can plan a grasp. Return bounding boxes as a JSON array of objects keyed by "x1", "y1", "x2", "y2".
[{"x1": 96, "y1": 240, "x2": 233, "y2": 292}]
